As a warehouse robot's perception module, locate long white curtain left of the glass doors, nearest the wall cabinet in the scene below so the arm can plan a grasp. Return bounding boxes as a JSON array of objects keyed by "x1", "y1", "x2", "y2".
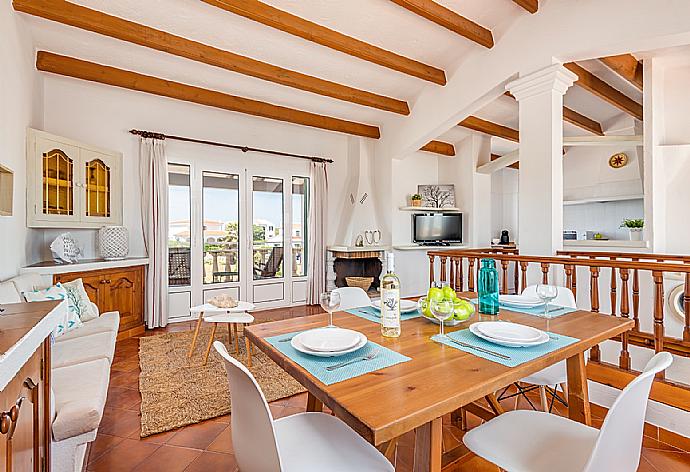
[{"x1": 139, "y1": 137, "x2": 168, "y2": 328}]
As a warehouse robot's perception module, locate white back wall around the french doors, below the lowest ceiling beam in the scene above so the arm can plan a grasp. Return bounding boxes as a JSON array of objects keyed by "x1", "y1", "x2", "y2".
[{"x1": 36, "y1": 76, "x2": 348, "y2": 260}]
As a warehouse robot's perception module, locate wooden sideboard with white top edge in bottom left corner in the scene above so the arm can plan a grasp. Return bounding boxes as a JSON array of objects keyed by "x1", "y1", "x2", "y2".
[{"x1": 0, "y1": 301, "x2": 59, "y2": 472}]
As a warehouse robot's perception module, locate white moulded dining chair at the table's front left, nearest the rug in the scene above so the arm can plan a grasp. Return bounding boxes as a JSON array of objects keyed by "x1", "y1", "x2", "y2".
[{"x1": 213, "y1": 341, "x2": 394, "y2": 472}]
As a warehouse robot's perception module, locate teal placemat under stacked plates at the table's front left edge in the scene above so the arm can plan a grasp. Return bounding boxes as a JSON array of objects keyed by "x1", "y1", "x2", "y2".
[{"x1": 266, "y1": 331, "x2": 412, "y2": 385}]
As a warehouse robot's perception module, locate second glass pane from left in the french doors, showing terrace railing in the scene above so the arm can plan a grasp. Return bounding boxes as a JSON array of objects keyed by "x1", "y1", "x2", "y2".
[{"x1": 203, "y1": 172, "x2": 240, "y2": 284}]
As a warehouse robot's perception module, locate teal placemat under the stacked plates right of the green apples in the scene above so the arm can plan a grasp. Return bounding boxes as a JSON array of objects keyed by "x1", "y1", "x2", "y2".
[{"x1": 431, "y1": 329, "x2": 579, "y2": 367}]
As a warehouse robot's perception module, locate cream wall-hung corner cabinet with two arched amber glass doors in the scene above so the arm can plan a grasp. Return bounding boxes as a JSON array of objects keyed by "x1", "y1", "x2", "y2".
[{"x1": 26, "y1": 129, "x2": 122, "y2": 228}]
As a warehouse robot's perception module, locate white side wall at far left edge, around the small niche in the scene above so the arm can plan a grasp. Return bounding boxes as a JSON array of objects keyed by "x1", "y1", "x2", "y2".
[{"x1": 0, "y1": 7, "x2": 42, "y2": 280}]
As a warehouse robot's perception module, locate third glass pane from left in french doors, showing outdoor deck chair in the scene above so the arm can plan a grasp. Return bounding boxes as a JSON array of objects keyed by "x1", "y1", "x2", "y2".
[{"x1": 252, "y1": 177, "x2": 284, "y2": 280}]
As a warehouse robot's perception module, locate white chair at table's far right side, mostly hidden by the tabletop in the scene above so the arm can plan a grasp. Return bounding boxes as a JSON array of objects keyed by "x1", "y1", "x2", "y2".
[{"x1": 499, "y1": 285, "x2": 577, "y2": 412}]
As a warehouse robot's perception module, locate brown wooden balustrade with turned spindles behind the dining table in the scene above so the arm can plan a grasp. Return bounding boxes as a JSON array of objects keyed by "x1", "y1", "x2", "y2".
[{"x1": 428, "y1": 249, "x2": 690, "y2": 411}]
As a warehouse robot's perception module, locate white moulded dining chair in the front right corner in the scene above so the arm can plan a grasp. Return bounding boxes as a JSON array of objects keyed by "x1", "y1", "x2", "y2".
[{"x1": 463, "y1": 352, "x2": 673, "y2": 472}]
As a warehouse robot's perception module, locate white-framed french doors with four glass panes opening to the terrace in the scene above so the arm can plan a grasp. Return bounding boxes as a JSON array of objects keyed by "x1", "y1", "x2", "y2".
[{"x1": 168, "y1": 151, "x2": 309, "y2": 321}]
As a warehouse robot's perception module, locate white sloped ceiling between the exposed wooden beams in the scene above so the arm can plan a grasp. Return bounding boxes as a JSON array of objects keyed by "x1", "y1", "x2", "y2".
[{"x1": 24, "y1": 0, "x2": 641, "y2": 154}]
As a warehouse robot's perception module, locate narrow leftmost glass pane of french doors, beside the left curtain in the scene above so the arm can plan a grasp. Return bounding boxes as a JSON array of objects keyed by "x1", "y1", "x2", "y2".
[{"x1": 168, "y1": 164, "x2": 192, "y2": 286}]
